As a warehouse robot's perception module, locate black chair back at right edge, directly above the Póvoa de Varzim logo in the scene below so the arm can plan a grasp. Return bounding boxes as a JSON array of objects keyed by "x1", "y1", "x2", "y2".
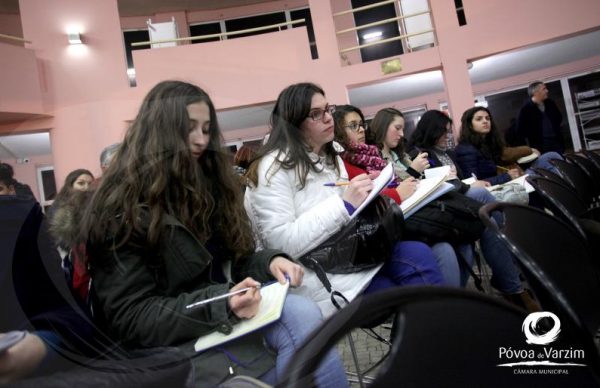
[{"x1": 479, "y1": 203, "x2": 600, "y2": 374}]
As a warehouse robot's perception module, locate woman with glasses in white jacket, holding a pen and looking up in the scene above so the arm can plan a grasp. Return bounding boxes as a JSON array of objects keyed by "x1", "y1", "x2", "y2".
[{"x1": 245, "y1": 83, "x2": 442, "y2": 316}]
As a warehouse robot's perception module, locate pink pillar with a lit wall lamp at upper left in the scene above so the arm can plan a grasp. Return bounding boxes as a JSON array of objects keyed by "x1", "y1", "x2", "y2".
[{"x1": 20, "y1": 0, "x2": 139, "y2": 181}]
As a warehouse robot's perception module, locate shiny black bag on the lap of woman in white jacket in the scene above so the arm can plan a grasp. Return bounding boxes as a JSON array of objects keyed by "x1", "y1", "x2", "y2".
[{"x1": 299, "y1": 196, "x2": 404, "y2": 281}]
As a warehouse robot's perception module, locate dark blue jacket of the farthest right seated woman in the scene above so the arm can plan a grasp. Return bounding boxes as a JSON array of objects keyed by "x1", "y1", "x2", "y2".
[{"x1": 455, "y1": 143, "x2": 511, "y2": 185}]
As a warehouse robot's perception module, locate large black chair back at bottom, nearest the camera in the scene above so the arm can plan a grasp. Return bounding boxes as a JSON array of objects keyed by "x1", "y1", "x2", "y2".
[{"x1": 280, "y1": 287, "x2": 598, "y2": 387}]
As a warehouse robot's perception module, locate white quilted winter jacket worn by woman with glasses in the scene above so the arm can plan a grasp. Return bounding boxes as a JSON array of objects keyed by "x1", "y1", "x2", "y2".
[{"x1": 244, "y1": 147, "x2": 380, "y2": 317}]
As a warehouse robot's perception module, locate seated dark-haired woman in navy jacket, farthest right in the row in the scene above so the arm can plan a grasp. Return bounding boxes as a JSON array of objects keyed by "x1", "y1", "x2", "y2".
[{"x1": 456, "y1": 107, "x2": 562, "y2": 185}]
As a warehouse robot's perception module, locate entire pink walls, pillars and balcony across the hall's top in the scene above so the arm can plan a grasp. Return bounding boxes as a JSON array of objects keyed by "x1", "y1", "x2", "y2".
[{"x1": 0, "y1": 0, "x2": 600, "y2": 181}]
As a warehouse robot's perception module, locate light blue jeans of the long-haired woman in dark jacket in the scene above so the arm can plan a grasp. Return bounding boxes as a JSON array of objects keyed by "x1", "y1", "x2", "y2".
[{"x1": 260, "y1": 294, "x2": 348, "y2": 387}]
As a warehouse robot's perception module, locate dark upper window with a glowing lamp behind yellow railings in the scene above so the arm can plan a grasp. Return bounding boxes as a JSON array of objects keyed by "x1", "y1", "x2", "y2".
[{"x1": 352, "y1": 0, "x2": 404, "y2": 62}]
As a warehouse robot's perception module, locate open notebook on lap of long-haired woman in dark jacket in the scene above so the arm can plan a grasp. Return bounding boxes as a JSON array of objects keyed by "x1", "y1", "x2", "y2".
[{"x1": 194, "y1": 282, "x2": 290, "y2": 352}]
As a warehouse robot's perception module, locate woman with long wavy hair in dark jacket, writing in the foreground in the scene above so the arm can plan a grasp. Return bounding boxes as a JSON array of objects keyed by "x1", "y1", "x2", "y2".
[{"x1": 83, "y1": 81, "x2": 346, "y2": 386}]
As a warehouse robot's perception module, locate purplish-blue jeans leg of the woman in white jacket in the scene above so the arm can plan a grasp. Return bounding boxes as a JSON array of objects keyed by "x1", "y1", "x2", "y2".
[{"x1": 364, "y1": 241, "x2": 444, "y2": 294}]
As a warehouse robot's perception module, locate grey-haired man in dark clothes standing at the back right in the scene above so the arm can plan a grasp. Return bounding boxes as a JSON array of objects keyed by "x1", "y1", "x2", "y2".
[{"x1": 517, "y1": 81, "x2": 565, "y2": 154}]
